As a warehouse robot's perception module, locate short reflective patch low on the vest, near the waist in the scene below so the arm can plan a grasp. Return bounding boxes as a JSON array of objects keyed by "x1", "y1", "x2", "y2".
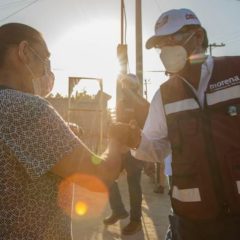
[{"x1": 172, "y1": 186, "x2": 201, "y2": 202}]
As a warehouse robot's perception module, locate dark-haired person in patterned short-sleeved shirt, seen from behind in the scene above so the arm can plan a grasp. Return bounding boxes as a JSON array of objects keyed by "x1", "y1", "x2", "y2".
[{"x1": 0, "y1": 23, "x2": 121, "y2": 240}]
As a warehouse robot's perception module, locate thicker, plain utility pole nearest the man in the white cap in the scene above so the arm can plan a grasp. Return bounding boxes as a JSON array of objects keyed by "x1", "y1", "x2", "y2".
[{"x1": 135, "y1": 0, "x2": 143, "y2": 95}]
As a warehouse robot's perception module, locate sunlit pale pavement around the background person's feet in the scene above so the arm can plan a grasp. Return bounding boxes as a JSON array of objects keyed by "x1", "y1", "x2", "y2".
[{"x1": 72, "y1": 174, "x2": 170, "y2": 240}]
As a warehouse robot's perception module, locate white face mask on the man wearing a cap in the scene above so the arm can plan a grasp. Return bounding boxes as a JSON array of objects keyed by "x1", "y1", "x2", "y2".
[{"x1": 160, "y1": 32, "x2": 195, "y2": 73}]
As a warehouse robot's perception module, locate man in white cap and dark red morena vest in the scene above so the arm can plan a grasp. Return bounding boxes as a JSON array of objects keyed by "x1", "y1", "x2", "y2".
[{"x1": 130, "y1": 9, "x2": 240, "y2": 240}]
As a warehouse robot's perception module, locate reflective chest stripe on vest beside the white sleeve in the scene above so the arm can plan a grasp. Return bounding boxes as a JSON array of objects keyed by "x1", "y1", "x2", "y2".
[{"x1": 164, "y1": 98, "x2": 199, "y2": 115}]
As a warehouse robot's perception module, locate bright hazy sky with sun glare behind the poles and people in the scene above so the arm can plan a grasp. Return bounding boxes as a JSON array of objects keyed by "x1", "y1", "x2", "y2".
[{"x1": 0, "y1": 0, "x2": 240, "y2": 107}]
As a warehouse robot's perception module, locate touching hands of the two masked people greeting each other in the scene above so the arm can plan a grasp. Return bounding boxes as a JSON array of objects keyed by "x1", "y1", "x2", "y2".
[{"x1": 108, "y1": 120, "x2": 141, "y2": 148}]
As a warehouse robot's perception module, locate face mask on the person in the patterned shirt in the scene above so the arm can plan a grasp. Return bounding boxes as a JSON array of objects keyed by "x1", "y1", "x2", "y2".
[{"x1": 26, "y1": 47, "x2": 55, "y2": 97}]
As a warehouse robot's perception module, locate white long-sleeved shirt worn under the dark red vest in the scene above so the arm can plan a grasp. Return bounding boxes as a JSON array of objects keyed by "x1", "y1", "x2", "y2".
[{"x1": 131, "y1": 56, "x2": 213, "y2": 165}]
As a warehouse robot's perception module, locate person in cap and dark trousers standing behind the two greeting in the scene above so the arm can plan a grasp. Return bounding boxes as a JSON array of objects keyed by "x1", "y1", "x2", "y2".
[{"x1": 104, "y1": 74, "x2": 149, "y2": 235}]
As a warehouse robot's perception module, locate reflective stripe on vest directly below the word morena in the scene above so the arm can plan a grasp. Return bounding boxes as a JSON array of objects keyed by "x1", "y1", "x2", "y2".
[{"x1": 207, "y1": 85, "x2": 240, "y2": 105}]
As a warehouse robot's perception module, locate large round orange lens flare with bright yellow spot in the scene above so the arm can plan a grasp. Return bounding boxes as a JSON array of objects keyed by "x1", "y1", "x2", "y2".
[{"x1": 58, "y1": 174, "x2": 108, "y2": 219}]
